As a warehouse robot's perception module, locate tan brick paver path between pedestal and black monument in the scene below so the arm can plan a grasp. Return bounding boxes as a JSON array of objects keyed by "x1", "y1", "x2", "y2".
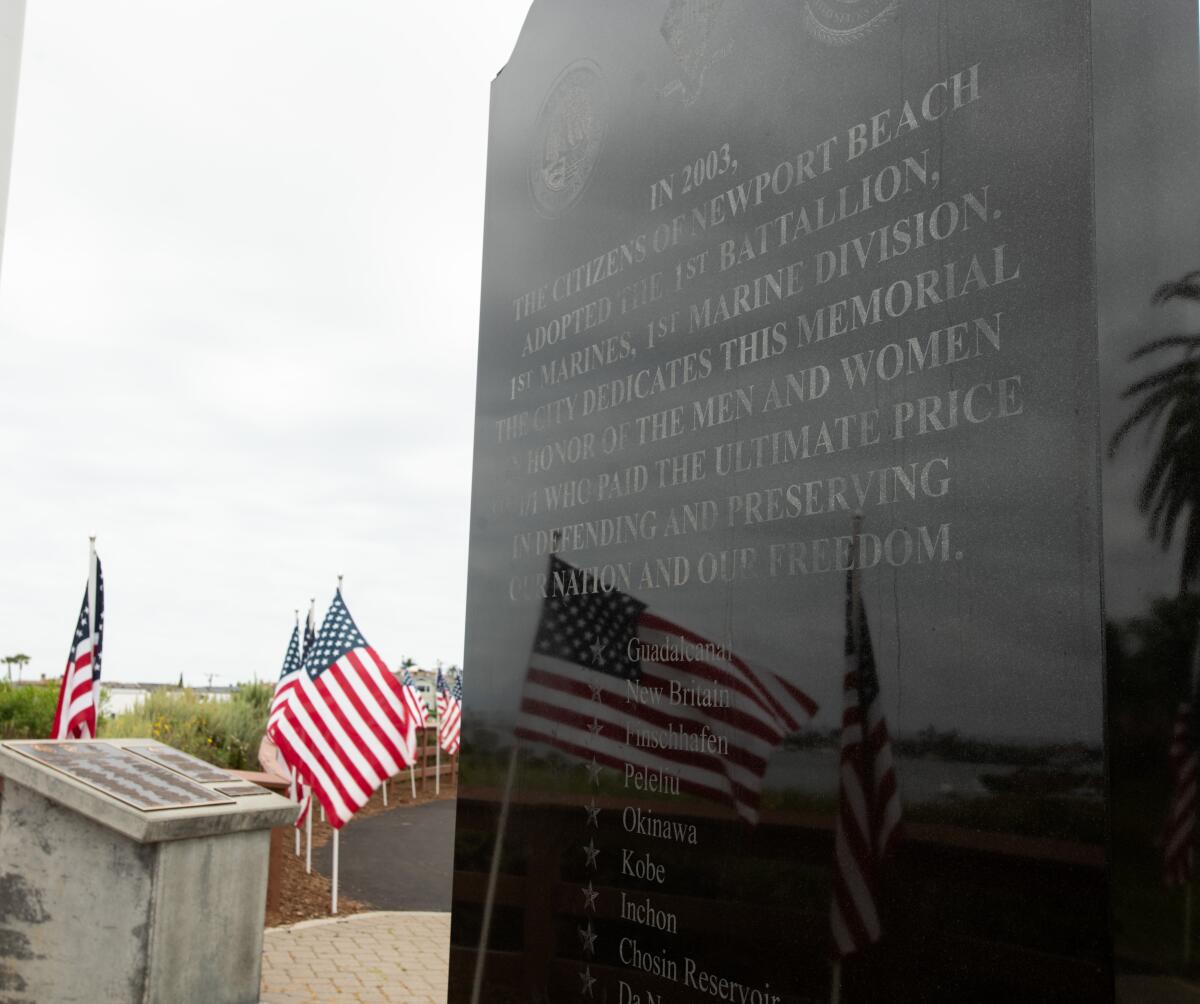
[{"x1": 263, "y1": 913, "x2": 450, "y2": 1004}]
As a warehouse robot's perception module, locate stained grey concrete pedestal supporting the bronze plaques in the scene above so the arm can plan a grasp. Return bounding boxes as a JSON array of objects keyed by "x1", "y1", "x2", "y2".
[{"x1": 0, "y1": 746, "x2": 296, "y2": 1004}]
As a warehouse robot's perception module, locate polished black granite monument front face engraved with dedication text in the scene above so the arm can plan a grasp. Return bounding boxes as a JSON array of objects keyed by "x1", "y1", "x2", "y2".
[{"x1": 450, "y1": 0, "x2": 1200, "y2": 1004}]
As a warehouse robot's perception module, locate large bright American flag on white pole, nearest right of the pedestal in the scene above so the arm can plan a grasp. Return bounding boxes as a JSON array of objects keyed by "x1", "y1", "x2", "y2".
[{"x1": 268, "y1": 590, "x2": 416, "y2": 829}]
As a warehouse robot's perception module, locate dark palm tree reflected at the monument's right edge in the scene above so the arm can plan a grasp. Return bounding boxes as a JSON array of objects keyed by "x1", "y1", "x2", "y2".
[{"x1": 1109, "y1": 271, "x2": 1200, "y2": 591}]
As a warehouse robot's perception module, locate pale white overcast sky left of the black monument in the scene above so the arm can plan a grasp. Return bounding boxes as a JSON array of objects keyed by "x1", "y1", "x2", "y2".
[{"x1": 0, "y1": 0, "x2": 528, "y2": 685}]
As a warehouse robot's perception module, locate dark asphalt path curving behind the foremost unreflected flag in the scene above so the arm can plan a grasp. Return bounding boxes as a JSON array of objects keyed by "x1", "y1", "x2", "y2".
[{"x1": 312, "y1": 799, "x2": 455, "y2": 912}]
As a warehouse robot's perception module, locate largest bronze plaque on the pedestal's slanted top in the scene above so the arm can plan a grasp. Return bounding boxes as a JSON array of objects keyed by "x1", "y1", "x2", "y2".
[{"x1": 4, "y1": 740, "x2": 233, "y2": 812}]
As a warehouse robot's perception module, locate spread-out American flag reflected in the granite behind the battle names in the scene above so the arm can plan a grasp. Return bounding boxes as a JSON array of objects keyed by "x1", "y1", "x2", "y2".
[{"x1": 516, "y1": 555, "x2": 816, "y2": 823}]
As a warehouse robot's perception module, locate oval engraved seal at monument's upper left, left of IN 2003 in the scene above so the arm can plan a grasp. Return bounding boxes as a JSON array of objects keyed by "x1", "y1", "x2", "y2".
[{"x1": 529, "y1": 60, "x2": 608, "y2": 220}]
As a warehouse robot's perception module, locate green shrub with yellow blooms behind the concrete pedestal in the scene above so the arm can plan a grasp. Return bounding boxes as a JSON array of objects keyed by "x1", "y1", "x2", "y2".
[{"x1": 100, "y1": 684, "x2": 274, "y2": 770}]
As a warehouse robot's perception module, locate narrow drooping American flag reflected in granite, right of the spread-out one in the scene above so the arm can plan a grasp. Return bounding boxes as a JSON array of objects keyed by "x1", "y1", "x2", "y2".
[{"x1": 830, "y1": 560, "x2": 900, "y2": 958}]
